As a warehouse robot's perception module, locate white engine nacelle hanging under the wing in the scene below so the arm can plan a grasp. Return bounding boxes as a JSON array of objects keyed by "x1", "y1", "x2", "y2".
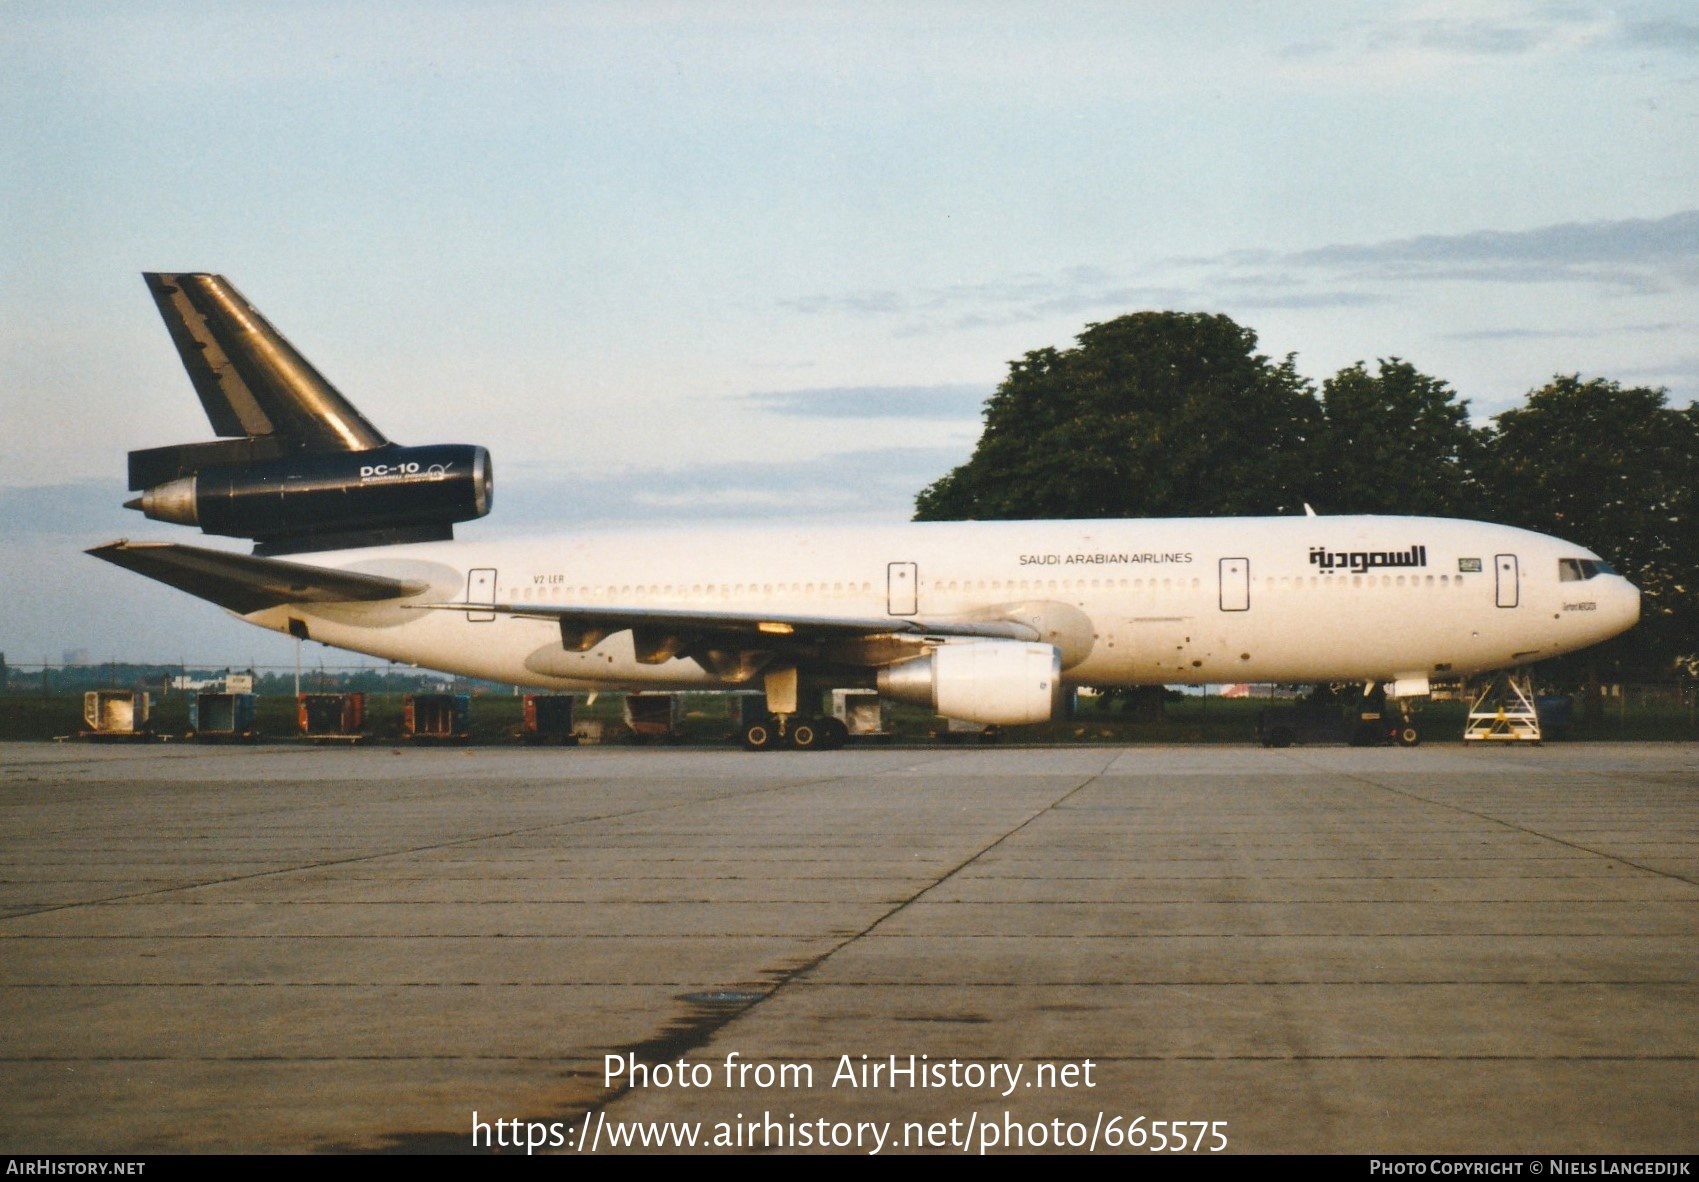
[{"x1": 878, "y1": 640, "x2": 1062, "y2": 727}]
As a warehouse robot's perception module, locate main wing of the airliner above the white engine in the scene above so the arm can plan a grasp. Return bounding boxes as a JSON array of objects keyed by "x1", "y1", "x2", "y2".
[{"x1": 409, "y1": 601, "x2": 1038, "y2": 664}]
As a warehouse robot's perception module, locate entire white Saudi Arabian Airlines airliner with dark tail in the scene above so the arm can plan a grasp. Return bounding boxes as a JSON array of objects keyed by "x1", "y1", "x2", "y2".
[{"x1": 90, "y1": 273, "x2": 1640, "y2": 749}]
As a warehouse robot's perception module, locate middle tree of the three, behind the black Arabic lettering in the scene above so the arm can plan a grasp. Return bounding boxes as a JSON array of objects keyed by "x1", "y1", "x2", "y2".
[{"x1": 1315, "y1": 357, "x2": 1487, "y2": 516}]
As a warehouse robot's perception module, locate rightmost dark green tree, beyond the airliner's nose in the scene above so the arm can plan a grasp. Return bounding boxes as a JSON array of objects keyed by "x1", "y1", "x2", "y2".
[{"x1": 1488, "y1": 375, "x2": 1699, "y2": 674}]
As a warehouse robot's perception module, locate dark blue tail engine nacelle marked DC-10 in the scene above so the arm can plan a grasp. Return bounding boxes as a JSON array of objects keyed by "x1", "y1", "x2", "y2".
[{"x1": 129, "y1": 443, "x2": 494, "y2": 554}]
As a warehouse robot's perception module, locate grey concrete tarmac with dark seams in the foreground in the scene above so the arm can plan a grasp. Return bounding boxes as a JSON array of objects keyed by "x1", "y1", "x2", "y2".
[{"x1": 0, "y1": 744, "x2": 1699, "y2": 1157}]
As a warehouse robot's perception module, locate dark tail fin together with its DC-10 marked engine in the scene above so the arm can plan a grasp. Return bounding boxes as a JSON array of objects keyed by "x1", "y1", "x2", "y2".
[{"x1": 126, "y1": 273, "x2": 494, "y2": 554}]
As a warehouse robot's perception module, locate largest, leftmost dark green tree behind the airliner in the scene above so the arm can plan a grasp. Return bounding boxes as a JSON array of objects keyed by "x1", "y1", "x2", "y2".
[{"x1": 914, "y1": 312, "x2": 1320, "y2": 521}]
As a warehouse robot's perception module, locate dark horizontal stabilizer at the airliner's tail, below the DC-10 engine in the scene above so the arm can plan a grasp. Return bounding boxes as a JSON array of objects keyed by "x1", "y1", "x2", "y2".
[{"x1": 88, "y1": 540, "x2": 428, "y2": 615}]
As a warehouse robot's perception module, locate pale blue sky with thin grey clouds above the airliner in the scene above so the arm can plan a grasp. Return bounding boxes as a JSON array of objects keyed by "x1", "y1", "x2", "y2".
[{"x1": 0, "y1": 0, "x2": 1699, "y2": 666}]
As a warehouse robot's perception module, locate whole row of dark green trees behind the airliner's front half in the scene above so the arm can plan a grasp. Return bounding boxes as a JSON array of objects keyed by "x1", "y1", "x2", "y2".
[{"x1": 914, "y1": 312, "x2": 1699, "y2": 676}]
